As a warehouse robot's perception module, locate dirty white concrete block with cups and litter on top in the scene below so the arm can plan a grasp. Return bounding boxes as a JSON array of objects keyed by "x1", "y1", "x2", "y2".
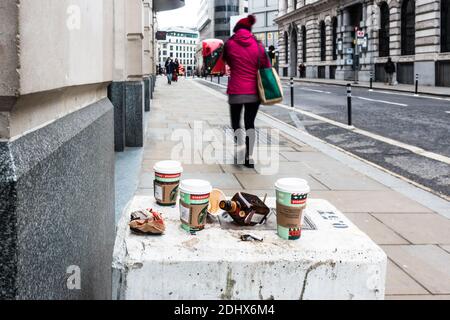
[{"x1": 113, "y1": 196, "x2": 387, "y2": 300}]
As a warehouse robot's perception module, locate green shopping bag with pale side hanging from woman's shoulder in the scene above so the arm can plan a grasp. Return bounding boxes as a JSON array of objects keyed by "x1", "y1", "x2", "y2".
[{"x1": 257, "y1": 41, "x2": 283, "y2": 105}]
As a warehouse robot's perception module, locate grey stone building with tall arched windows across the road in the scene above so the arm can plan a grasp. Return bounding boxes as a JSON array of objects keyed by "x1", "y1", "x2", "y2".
[{"x1": 276, "y1": 0, "x2": 450, "y2": 86}]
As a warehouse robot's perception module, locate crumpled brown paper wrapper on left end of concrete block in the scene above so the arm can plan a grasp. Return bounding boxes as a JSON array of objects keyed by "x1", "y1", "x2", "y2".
[{"x1": 129, "y1": 209, "x2": 166, "y2": 235}]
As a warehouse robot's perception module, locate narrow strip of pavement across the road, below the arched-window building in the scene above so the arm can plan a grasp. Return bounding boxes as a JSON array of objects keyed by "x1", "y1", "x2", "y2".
[{"x1": 281, "y1": 77, "x2": 450, "y2": 97}]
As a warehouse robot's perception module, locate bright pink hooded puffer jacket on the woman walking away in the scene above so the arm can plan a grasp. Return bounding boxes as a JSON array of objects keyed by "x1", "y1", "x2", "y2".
[{"x1": 223, "y1": 29, "x2": 271, "y2": 94}]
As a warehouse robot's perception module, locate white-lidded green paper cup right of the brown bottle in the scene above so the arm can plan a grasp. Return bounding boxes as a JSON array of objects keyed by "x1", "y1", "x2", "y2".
[{"x1": 275, "y1": 178, "x2": 311, "y2": 240}]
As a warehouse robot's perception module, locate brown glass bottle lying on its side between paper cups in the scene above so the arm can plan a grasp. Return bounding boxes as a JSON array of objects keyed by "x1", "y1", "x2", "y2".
[{"x1": 219, "y1": 192, "x2": 270, "y2": 226}]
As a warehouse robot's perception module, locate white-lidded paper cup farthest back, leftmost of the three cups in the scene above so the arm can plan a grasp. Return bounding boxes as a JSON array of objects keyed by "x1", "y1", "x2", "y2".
[{"x1": 153, "y1": 160, "x2": 183, "y2": 206}]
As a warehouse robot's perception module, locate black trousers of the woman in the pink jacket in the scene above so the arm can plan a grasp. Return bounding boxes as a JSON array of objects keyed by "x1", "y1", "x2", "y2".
[{"x1": 230, "y1": 102, "x2": 260, "y2": 158}]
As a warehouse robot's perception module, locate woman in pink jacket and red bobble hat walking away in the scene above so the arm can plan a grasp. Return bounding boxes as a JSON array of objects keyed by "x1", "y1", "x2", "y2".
[{"x1": 223, "y1": 15, "x2": 271, "y2": 168}]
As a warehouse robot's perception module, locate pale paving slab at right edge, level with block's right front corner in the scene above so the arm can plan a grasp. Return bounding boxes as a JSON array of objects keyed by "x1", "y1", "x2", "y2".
[{"x1": 382, "y1": 245, "x2": 450, "y2": 294}]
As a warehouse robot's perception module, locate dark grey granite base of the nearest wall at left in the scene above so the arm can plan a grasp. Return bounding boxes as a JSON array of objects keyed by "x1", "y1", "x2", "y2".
[{"x1": 0, "y1": 99, "x2": 115, "y2": 299}]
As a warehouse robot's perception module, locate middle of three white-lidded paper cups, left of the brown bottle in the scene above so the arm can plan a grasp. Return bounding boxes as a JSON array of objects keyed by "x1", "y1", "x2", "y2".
[{"x1": 180, "y1": 179, "x2": 212, "y2": 232}]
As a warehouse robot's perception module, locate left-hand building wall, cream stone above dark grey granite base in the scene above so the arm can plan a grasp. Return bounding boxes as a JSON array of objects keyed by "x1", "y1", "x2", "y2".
[{"x1": 0, "y1": 0, "x2": 184, "y2": 300}]
